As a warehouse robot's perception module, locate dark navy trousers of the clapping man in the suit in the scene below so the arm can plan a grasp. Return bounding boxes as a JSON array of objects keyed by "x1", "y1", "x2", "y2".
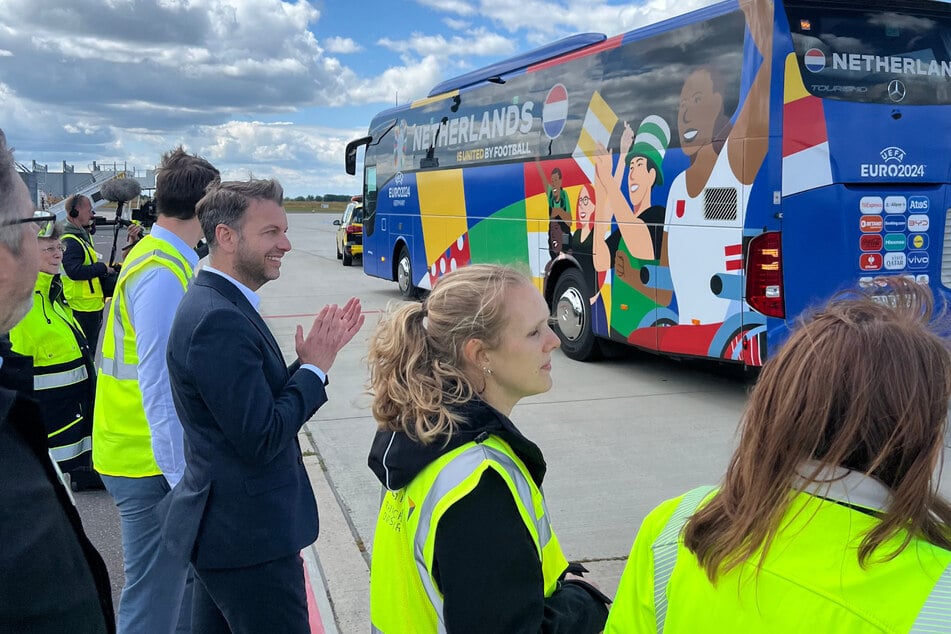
[{"x1": 192, "y1": 554, "x2": 310, "y2": 634}]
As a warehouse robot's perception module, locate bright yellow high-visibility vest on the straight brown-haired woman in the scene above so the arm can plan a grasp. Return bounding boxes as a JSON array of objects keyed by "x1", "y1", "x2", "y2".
[{"x1": 605, "y1": 479, "x2": 951, "y2": 634}]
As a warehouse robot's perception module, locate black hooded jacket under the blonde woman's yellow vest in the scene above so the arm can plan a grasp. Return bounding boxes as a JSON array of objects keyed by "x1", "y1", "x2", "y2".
[{"x1": 369, "y1": 400, "x2": 608, "y2": 634}]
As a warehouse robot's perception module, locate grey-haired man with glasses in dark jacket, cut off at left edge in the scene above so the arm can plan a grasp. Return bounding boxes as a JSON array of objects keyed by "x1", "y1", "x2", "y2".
[{"x1": 0, "y1": 130, "x2": 116, "y2": 634}]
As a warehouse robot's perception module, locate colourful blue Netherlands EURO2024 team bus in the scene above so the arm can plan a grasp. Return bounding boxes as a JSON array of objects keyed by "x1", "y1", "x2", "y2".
[{"x1": 346, "y1": 0, "x2": 951, "y2": 366}]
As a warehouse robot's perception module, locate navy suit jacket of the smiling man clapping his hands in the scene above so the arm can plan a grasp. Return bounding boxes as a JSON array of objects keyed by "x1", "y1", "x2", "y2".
[{"x1": 158, "y1": 271, "x2": 327, "y2": 568}]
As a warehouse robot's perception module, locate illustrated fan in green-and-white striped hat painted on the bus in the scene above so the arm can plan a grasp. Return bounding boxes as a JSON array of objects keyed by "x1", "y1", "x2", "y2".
[{"x1": 595, "y1": 115, "x2": 671, "y2": 338}]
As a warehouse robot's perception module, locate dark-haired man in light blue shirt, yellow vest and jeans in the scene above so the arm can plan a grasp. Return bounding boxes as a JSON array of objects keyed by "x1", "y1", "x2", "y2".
[{"x1": 93, "y1": 148, "x2": 219, "y2": 634}]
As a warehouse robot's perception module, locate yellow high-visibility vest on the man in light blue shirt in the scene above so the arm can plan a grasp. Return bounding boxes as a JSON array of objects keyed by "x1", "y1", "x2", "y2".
[{"x1": 92, "y1": 235, "x2": 192, "y2": 478}]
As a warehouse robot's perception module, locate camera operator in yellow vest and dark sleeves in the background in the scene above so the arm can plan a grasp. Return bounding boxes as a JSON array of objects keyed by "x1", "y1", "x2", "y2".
[{"x1": 63, "y1": 194, "x2": 142, "y2": 352}]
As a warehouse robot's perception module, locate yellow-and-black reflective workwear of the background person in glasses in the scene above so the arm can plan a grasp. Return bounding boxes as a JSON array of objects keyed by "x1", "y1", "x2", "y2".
[{"x1": 10, "y1": 271, "x2": 95, "y2": 471}]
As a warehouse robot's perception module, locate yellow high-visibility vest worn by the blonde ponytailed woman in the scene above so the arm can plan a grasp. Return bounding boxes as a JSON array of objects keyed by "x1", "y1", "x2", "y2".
[{"x1": 370, "y1": 436, "x2": 568, "y2": 634}]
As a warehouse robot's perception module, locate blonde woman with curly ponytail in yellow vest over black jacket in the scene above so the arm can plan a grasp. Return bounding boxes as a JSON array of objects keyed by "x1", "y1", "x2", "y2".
[{"x1": 369, "y1": 265, "x2": 607, "y2": 634}]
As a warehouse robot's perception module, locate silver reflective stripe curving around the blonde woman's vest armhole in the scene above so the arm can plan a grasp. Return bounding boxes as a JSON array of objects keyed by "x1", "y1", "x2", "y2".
[{"x1": 413, "y1": 444, "x2": 551, "y2": 633}]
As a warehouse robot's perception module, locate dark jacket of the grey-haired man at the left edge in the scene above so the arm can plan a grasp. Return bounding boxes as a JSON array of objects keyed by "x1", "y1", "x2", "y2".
[{"x1": 0, "y1": 336, "x2": 116, "y2": 634}]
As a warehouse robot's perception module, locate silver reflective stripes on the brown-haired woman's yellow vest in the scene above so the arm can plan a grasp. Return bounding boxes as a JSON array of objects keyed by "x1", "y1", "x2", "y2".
[{"x1": 651, "y1": 487, "x2": 951, "y2": 634}]
